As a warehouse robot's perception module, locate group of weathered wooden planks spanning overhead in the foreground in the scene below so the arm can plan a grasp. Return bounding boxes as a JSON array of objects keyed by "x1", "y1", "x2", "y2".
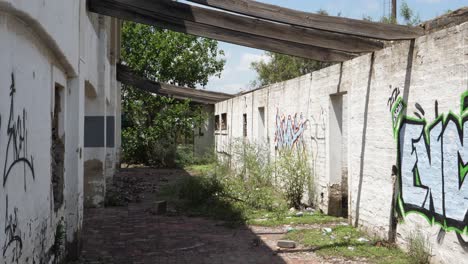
[{"x1": 88, "y1": 0, "x2": 424, "y2": 62}]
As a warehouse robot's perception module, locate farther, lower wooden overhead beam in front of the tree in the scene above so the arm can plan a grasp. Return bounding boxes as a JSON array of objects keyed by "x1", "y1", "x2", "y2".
[{"x1": 117, "y1": 64, "x2": 234, "y2": 104}]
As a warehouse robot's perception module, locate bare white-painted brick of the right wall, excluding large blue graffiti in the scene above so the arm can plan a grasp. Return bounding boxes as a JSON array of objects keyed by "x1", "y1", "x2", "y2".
[{"x1": 216, "y1": 20, "x2": 468, "y2": 263}]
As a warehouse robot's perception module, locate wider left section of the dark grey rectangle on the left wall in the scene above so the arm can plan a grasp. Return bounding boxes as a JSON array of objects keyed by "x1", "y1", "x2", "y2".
[{"x1": 84, "y1": 116, "x2": 105, "y2": 148}]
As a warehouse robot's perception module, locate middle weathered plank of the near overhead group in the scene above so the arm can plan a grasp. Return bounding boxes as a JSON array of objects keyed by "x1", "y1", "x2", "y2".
[{"x1": 105, "y1": 0, "x2": 384, "y2": 52}]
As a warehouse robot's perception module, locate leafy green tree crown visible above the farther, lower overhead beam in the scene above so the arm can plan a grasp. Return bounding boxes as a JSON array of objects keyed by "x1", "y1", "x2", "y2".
[{"x1": 122, "y1": 22, "x2": 225, "y2": 88}]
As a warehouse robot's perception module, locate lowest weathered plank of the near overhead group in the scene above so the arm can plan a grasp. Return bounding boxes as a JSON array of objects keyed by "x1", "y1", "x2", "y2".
[{"x1": 88, "y1": 0, "x2": 356, "y2": 62}]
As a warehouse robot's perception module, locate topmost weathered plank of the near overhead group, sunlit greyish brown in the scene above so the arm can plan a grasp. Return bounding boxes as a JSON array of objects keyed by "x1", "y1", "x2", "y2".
[{"x1": 188, "y1": 0, "x2": 424, "y2": 40}]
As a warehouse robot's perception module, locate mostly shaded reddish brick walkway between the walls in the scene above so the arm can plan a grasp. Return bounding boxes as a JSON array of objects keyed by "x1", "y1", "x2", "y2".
[{"x1": 77, "y1": 169, "x2": 323, "y2": 264}]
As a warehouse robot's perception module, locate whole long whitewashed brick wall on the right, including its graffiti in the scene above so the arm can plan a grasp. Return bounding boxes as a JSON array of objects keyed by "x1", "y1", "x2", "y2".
[{"x1": 215, "y1": 23, "x2": 468, "y2": 263}]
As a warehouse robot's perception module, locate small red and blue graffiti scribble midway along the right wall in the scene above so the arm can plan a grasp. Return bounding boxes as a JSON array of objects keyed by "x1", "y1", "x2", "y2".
[{"x1": 275, "y1": 110, "x2": 309, "y2": 150}]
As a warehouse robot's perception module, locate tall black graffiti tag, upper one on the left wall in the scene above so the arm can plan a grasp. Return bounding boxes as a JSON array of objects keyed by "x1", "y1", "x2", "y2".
[{"x1": 0, "y1": 74, "x2": 35, "y2": 191}]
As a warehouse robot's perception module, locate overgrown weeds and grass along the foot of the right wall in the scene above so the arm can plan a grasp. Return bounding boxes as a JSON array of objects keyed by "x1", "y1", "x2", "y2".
[{"x1": 158, "y1": 142, "x2": 416, "y2": 264}]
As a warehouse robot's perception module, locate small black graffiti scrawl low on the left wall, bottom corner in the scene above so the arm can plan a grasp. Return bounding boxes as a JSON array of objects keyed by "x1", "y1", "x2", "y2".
[{"x1": 2, "y1": 196, "x2": 23, "y2": 263}]
